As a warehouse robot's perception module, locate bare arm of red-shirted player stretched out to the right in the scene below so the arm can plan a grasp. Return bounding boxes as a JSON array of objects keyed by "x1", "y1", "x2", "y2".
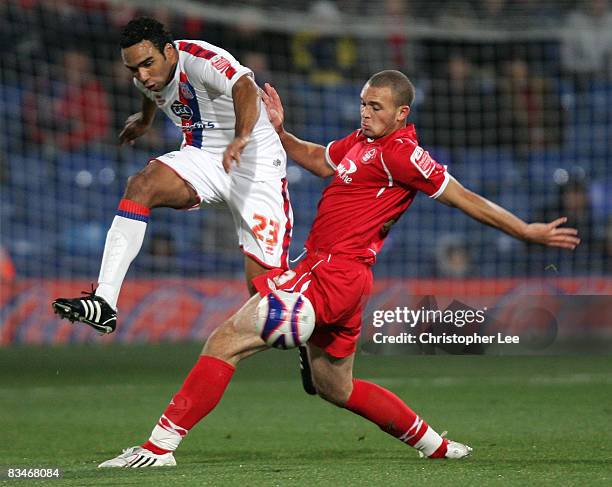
[{"x1": 438, "y1": 176, "x2": 580, "y2": 250}]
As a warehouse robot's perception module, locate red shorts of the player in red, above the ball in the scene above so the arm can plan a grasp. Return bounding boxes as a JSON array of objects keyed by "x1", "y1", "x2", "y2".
[{"x1": 253, "y1": 252, "x2": 372, "y2": 358}]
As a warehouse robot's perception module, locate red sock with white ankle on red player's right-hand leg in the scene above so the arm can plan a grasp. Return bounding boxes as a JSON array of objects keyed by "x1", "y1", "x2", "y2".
[{"x1": 344, "y1": 379, "x2": 446, "y2": 456}]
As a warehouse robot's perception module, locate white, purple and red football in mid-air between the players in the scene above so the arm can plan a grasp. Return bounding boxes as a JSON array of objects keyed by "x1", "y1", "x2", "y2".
[{"x1": 255, "y1": 291, "x2": 315, "y2": 349}]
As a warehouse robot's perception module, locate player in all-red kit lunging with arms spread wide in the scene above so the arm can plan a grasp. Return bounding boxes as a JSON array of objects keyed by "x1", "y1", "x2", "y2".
[{"x1": 100, "y1": 71, "x2": 580, "y2": 467}]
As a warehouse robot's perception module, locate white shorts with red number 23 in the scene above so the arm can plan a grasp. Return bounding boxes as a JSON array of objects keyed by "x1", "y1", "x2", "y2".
[{"x1": 155, "y1": 146, "x2": 293, "y2": 269}]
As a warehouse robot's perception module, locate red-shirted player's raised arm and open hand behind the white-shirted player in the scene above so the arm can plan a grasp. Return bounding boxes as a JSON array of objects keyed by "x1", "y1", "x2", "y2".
[{"x1": 261, "y1": 83, "x2": 334, "y2": 178}]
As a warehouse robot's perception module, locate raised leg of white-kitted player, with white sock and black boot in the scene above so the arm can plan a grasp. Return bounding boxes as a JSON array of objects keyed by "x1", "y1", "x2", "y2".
[{"x1": 53, "y1": 160, "x2": 199, "y2": 333}]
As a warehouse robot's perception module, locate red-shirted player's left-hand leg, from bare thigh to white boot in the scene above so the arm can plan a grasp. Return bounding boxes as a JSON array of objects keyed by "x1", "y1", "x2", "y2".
[{"x1": 99, "y1": 295, "x2": 268, "y2": 468}]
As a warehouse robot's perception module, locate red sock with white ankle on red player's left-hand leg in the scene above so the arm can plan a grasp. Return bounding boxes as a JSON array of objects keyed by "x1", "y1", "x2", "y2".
[{"x1": 142, "y1": 355, "x2": 235, "y2": 455}]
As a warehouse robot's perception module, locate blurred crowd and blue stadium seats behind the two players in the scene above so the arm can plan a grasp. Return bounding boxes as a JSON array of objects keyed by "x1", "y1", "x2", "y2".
[{"x1": 0, "y1": 0, "x2": 612, "y2": 278}]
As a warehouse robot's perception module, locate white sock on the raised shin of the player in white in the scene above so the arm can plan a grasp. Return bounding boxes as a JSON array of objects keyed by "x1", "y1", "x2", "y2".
[{"x1": 96, "y1": 212, "x2": 148, "y2": 310}]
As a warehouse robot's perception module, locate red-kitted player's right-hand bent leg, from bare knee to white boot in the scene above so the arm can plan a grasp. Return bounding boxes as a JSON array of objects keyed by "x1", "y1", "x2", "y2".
[{"x1": 308, "y1": 344, "x2": 472, "y2": 458}]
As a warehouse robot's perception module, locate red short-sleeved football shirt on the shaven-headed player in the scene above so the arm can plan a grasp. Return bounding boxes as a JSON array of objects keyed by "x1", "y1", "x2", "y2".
[{"x1": 306, "y1": 124, "x2": 449, "y2": 263}]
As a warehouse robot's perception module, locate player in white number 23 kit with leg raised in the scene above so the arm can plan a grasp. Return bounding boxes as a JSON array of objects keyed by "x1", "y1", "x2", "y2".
[{"x1": 53, "y1": 17, "x2": 293, "y2": 333}]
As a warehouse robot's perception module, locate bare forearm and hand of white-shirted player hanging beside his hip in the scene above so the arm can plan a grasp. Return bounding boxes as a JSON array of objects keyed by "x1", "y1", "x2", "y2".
[{"x1": 223, "y1": 74, "x2": 259, "y2": 173}]
